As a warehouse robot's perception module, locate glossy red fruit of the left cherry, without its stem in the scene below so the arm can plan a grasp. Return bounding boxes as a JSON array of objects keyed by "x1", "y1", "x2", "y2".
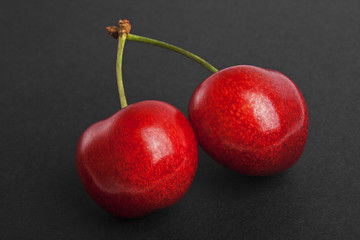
[{"x1": 76, "y1": 101, "x2": 198, "y2": 218}]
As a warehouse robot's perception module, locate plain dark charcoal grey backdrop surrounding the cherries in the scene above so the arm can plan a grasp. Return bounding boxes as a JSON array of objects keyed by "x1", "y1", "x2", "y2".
[{"x1": 0, "y1": 0, "x2": 360, "y2": 239}]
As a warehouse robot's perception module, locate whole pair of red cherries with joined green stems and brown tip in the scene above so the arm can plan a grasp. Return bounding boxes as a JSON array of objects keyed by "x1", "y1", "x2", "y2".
[{"x1": 76, "y1": 20, "x2": 308, "y2": 218}]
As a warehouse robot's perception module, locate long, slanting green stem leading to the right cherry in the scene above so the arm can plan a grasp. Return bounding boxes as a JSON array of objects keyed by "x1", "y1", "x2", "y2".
[{"x1": 124, "y1": 34, "x2": 218, "y2": 73}]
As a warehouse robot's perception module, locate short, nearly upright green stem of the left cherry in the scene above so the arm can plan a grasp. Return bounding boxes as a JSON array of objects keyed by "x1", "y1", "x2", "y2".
[{"x1": 116, "y1": 34, "x2": 127, "y2": 108}]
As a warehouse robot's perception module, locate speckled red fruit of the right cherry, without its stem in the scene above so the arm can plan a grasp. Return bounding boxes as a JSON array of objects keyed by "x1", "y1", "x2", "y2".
[{"x1": 188, "y1": 65, "x2": 309, "y2": 176}]
